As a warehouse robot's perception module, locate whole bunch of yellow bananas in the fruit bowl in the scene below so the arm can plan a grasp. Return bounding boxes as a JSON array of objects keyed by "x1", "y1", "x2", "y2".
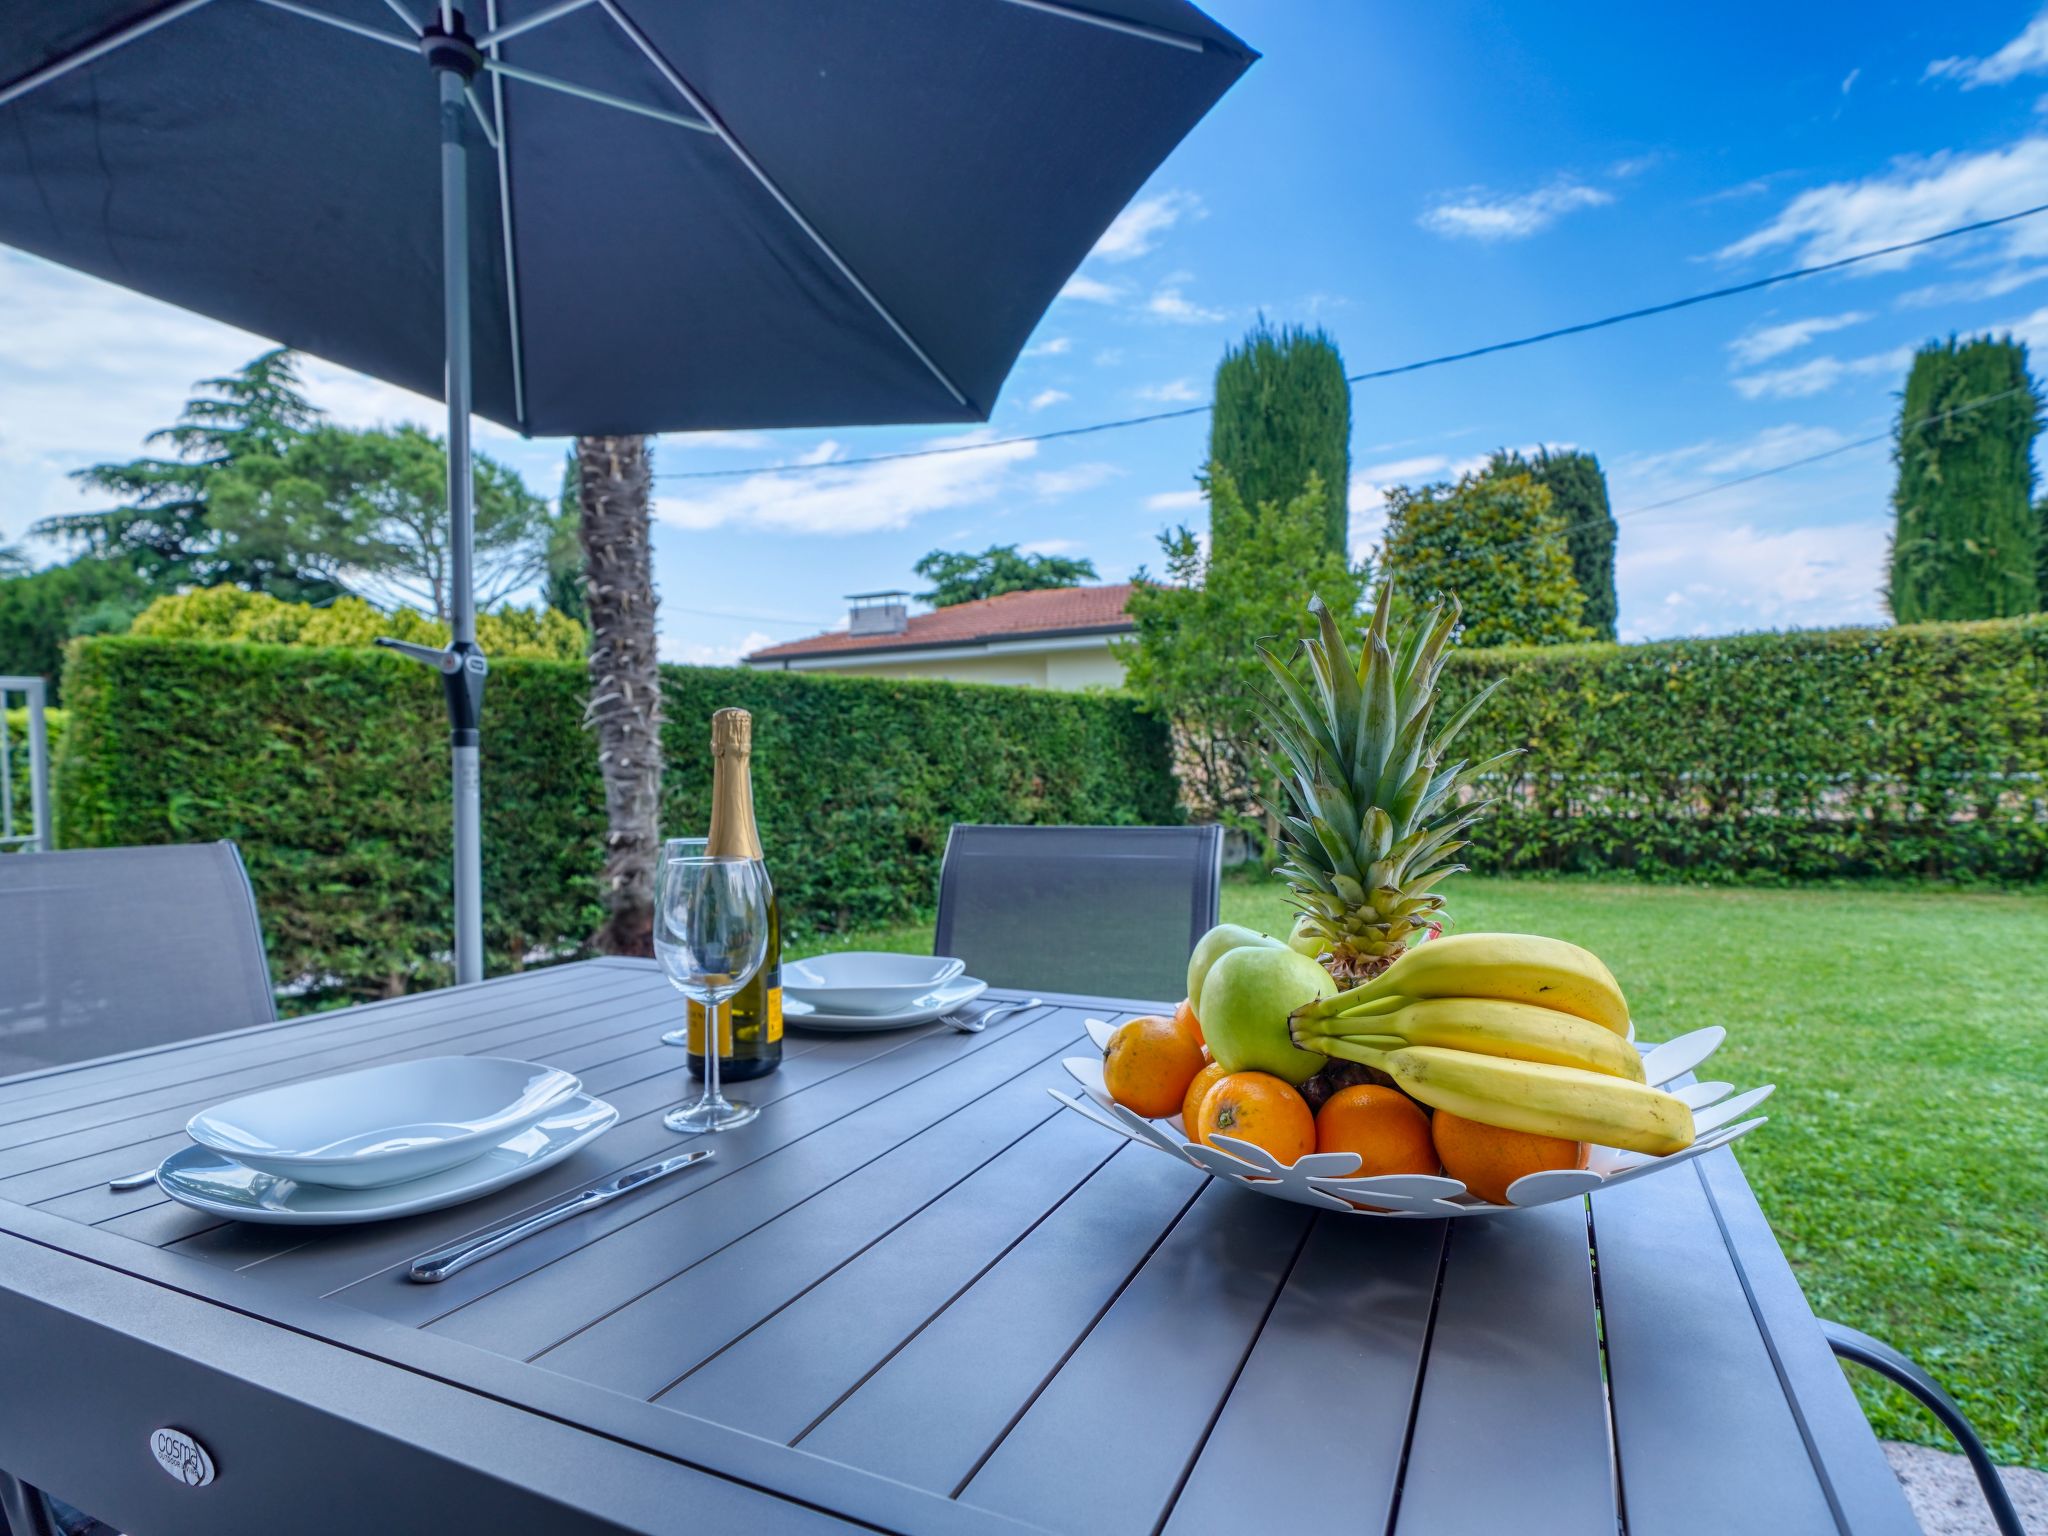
[{"x1": 1288, "y1": 934, "x2": 1694, "y2": 1155}]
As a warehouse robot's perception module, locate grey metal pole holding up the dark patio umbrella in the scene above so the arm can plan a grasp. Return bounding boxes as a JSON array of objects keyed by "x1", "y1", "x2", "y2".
[{"x1": 434, "y1": 59, "x2": 489, "y2": 983}]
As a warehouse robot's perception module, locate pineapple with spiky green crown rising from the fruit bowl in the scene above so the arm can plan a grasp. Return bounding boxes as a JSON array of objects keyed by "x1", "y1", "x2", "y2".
[{"x1": 1260, "y1": 582, "x2": 1516, "y2": 987}]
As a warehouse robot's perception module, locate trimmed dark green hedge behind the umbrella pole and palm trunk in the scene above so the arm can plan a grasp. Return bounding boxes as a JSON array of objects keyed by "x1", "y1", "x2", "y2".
[{"x1": 57, "y1": 637, "x2": 1178, "y2": 1001}]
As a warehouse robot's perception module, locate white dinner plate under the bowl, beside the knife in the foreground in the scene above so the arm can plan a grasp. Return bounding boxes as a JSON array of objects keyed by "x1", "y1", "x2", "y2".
[{"x1": 156, "y1": 1094, "x2": 618, "y2": 1227}]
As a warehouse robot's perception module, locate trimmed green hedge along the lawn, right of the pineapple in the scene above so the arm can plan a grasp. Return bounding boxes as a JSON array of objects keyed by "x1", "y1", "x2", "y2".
[{"x1": 1448, "y1": 616, "x2": 2048, "y2": 883}]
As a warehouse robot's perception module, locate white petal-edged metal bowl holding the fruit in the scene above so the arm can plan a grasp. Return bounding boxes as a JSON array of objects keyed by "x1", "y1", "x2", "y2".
[{"x1": 1049, "y1": 1018, "x2": 1772, "y2": 1217}]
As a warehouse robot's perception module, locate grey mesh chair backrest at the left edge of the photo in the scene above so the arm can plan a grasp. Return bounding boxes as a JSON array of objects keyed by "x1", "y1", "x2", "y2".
[{"x1": 0, "y1": 842, "x2": 276, "y2": 1077}]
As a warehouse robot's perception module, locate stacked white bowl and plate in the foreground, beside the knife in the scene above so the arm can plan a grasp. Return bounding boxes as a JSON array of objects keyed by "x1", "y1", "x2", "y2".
[{"x1": 156, "y1": 1057, "x2": 618, "y2": 1223}]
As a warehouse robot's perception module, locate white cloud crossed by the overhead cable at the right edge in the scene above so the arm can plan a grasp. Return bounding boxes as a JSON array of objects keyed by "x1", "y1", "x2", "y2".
[{"x1": 1718, "y1": 137, "x2": 2048, "y2": 272}]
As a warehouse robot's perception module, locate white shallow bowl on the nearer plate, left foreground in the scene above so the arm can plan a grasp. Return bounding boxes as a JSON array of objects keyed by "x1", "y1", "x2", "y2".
[{"x1": 184, "y1": 1057, "x2": 582, "y2": 1190}]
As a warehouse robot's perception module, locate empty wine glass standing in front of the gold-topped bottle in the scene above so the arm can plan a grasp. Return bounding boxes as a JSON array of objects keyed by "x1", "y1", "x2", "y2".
[{"x1": 653, "y1": 854, "x2": 768, "y2": 1130}]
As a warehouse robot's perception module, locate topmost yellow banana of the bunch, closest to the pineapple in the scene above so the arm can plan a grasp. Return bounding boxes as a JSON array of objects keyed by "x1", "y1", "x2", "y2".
[{"x1": 1315, "y1": 934, "x2": 1628, "y2": 1034}]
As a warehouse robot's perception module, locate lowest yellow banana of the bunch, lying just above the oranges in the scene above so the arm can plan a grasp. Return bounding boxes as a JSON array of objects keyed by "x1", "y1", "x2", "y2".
[{"x1": 1329, "y1": 1040, "x2": 1694, "y2": 1157}]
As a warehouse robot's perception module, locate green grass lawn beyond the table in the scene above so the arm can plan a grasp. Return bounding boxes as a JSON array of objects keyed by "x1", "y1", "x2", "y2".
[{"x1": 815, "y1": 877, "x2": 2048, "y2": 1468}]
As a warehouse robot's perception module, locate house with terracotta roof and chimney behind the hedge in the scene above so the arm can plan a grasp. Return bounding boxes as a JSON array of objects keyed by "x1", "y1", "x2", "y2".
[{"x1": 745, "y1": 582, "x2": 1133, "y2": 688}]
